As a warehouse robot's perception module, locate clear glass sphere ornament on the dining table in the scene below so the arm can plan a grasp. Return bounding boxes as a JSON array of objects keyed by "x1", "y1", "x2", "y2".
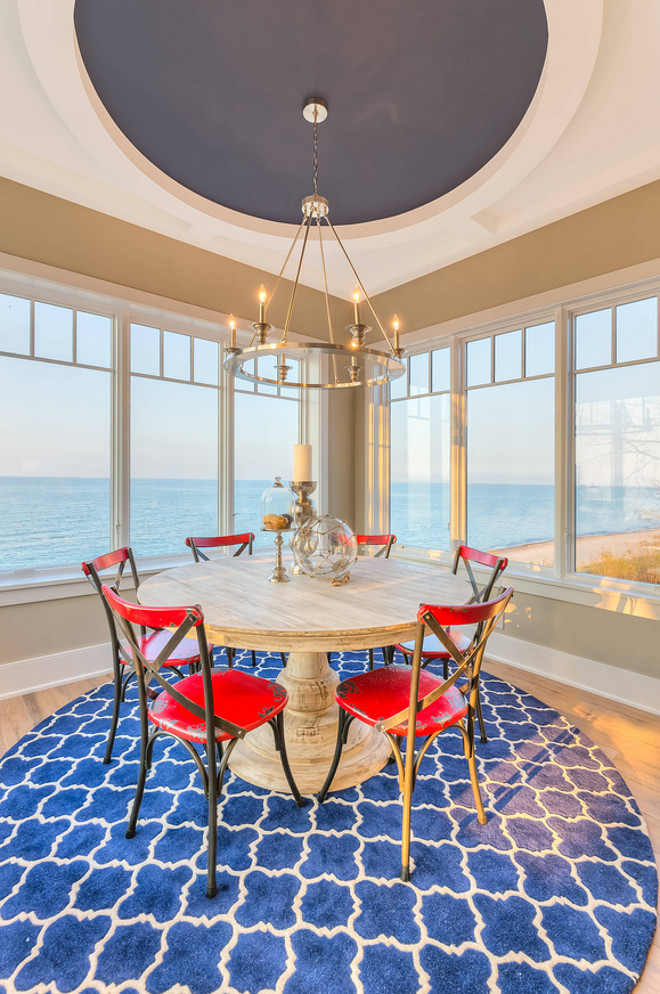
[{"x1": 291, "y1": 514, "x2": 357, "y2": 584}]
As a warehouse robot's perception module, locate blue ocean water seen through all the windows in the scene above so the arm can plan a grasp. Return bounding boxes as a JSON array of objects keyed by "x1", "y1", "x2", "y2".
[{"x1": 0, "y1": 477, "x2": 660, "y2": 570}]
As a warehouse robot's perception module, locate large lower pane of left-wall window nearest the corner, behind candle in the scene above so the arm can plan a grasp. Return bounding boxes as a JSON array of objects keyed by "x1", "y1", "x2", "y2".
[{"x1": 233, "y1": 394, "x2": 300, "y2": 552}]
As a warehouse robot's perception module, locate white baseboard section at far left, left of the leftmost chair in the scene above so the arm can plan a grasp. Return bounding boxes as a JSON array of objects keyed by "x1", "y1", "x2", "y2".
[{"x1": 0, "y1": 642, "x2": 112, "y2": 700}]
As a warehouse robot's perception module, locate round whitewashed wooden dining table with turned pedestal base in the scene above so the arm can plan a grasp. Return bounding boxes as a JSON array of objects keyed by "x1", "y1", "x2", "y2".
[{"x1": 138, "y1": 556, "x2": 473, "y2": 793}]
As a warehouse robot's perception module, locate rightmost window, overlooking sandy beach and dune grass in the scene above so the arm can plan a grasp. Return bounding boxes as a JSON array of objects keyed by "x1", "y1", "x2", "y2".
[{"x1": 573, "y1": 297, "x2": 660, "y2": 584}]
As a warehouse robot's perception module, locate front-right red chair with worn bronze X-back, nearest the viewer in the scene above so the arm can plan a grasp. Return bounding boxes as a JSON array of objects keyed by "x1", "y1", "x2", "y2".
[{"x1": 317, "y1": 587, "x2": 513, "y2": 880}]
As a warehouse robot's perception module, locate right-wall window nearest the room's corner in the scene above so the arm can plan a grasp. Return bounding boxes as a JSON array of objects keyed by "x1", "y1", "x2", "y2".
[{"x1": 390, "y1": 348, "x2": 450, "y2": 550}]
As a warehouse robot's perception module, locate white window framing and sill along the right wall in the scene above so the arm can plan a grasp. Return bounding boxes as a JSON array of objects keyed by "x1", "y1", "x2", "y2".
[{"x1": 384, "y1": 265, "x2": 660, "y2": 619}]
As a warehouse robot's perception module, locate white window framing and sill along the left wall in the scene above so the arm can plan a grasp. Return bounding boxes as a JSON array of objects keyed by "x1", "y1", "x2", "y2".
[{"x1": 0, "y1": 257, "x2": 310, "y2": 606}]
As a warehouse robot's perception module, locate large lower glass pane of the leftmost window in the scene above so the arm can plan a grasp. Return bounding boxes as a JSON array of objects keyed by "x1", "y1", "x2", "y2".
[{"x1": 0, "y1": 358, "x2": 111, "y2": 570}]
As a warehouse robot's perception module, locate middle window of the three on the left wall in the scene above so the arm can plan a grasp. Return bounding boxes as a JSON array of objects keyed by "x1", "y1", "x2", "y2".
[{"x1": 130, "y1": 324, "x2": 219, "y2": 556}]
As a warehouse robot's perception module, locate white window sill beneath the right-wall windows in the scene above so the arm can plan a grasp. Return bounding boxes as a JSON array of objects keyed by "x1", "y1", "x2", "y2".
[{"x1": 392, "y1": 546, "x2": 660, "y2": 621}]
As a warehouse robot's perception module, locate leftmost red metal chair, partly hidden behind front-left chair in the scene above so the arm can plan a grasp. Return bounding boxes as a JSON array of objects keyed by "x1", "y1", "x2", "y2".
[{"x1": 80, "y1": 546, "x2": 214, "y2": 764}]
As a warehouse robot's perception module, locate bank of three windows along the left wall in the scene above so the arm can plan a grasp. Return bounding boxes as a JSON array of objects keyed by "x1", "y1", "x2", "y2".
[{"x1": 0, "y1": 273, "x2": 318, "y2": 587}]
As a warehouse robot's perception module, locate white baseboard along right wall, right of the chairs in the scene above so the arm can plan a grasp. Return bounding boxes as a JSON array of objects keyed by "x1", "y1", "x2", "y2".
[{"x1": 484, "y1": 632, "x2": 660, "y2": 714}]
